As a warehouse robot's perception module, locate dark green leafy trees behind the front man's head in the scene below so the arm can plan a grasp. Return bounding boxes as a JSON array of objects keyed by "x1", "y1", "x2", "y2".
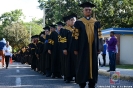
[{"x1": 38, "y1": 0, "x2": 133, "y2": 29}]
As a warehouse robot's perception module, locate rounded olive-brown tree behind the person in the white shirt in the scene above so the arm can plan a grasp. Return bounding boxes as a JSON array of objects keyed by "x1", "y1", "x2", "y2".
[{"x1": 2, "y1": 22, "x2": 29, "y2": 50}]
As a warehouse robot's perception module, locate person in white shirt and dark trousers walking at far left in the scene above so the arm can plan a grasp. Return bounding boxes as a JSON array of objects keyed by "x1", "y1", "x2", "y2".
[{"x1": 3, "y1": 41, "x2": 12, "y2": 69}]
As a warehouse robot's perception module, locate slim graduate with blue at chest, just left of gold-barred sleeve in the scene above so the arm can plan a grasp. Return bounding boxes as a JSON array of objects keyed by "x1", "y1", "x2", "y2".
[{"x1": 43, "y1": 26, "x2": 51, "y2": 77}]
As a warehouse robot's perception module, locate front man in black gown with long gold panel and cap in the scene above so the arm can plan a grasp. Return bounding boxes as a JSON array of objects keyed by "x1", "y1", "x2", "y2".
[{"x1": 74, "y1": 2, "x2": 103, "y2": 88}]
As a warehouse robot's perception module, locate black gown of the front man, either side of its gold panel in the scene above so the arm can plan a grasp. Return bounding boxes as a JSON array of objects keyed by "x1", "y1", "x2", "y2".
[{"x1": 74, "y1": 21, "x2": 100, "y2": 84}]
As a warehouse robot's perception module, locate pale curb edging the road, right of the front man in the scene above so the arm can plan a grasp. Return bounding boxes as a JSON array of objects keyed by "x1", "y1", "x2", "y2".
[{"x1": 98, "y1": 70, "x2": 133, "y2": 82}]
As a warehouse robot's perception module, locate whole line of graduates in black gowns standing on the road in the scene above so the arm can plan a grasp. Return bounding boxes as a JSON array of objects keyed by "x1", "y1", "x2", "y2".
[{"x1": 19, "y1": 2, "x2": 102, "y2": 88}]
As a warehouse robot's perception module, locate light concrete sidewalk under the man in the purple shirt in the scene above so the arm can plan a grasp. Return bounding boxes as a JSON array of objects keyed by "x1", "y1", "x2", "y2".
[{"x1": 99, "y1": 67, "x2": 133, "y2": 81}]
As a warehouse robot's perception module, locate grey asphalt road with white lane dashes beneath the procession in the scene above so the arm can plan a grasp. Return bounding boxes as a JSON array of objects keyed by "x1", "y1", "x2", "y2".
[{"x1": 0, "y1": 62, "x2": 133, "y2": 88}]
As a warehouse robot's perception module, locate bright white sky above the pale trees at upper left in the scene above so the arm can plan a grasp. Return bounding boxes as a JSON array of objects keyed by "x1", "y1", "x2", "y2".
[{"x1": 0, "y1": 0, "x2": 43, "y2": 22}]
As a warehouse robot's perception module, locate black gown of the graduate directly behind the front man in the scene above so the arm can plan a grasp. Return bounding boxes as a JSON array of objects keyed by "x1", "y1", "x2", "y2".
[{"x1": 61, "y1": 29, "x2": 76, "y2": 80}]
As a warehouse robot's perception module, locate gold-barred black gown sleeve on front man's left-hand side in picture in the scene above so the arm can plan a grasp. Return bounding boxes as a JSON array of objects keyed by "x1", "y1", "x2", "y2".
[{"x1": 72, "y1": 21, "x2": 81, "y2": 51}]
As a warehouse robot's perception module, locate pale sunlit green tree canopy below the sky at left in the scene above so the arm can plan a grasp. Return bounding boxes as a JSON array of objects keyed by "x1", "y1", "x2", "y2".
[{"x1": 0, "y1": 10, "x2": 42, "y2": 50}]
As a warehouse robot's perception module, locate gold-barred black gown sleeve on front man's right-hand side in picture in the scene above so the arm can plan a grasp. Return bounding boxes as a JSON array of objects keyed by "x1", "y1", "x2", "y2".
[{"x1": 95, "y1": 21, "x2": 103, "y2": 51}]
